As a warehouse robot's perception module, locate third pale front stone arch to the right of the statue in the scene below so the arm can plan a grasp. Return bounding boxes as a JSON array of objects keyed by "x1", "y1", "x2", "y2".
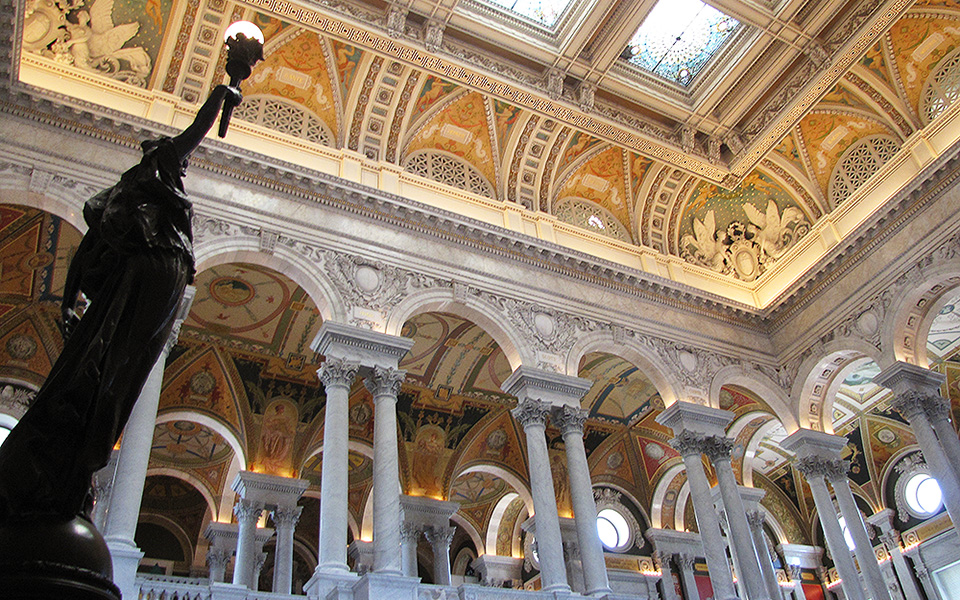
[{"x1": 566, "y1": 331, "x2": 682, "y2": 406}]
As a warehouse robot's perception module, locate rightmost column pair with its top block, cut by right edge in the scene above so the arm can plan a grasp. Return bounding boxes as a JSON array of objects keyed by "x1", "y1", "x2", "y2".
[{"x1": 873, "y1": 362, "x2": 960, "y2": 525}]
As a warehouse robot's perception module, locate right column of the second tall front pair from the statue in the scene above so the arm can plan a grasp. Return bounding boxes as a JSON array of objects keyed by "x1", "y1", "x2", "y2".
[{"x1": 553, "y1": 405, "x2": 611, "y2": 596}]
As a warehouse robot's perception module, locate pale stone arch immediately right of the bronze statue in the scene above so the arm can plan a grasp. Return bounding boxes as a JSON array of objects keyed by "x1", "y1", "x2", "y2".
[{"x1": 194, "y1": 236, "x2": 347, "y2": 324}]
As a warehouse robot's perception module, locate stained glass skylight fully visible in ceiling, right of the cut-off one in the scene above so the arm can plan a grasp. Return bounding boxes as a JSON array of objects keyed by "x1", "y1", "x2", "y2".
[{"x1": 624, "y1": 0, "x2": 740, "y2": 86}]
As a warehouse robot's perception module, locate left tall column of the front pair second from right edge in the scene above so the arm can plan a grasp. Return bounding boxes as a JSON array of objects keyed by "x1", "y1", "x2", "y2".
[{"x1": 794, "y1": 457, "x2": 868, "y2": 600}]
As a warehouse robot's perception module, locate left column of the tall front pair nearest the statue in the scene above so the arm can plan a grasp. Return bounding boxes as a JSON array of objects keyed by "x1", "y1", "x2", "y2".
[{"x1": 317, "y1": 358, "x2": 359, "y2": 572}]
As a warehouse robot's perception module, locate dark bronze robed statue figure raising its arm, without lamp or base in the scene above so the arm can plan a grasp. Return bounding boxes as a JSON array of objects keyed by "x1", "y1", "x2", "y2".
[{"x1": 0, "y1": 85, "x2": 240, "y2": 525}]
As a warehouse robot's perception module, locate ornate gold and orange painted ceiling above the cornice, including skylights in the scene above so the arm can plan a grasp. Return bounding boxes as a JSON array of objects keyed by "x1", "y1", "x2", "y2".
[{"x1": 21, "y1": 0, "x2": 960, "y2": 296}]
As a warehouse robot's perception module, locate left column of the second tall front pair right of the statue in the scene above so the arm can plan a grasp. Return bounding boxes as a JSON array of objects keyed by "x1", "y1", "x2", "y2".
[{"x1": 512, "y1": 398, "x2": 570, "y2": 592}]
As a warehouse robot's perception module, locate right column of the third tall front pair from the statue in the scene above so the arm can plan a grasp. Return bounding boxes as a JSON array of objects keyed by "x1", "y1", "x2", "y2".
[{"x1": 704, "y1": 437, "x2": 779, "y2": 600}]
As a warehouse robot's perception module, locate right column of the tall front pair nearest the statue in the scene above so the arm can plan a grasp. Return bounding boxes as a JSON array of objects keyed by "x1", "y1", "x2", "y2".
[{"x1": 364, "y1": 367, "x2": 406, "y2": 575}]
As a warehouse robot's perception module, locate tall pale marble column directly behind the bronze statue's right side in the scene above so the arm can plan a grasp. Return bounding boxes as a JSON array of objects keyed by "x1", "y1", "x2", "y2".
[{"x1": 103, "y1": 286, "x2": 197, "y2": 598}]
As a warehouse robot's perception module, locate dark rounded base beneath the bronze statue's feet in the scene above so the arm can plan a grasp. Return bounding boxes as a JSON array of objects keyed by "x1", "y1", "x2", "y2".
[{"x1": 0, "y1": 517, "x2": 120, "y2": 600}]
